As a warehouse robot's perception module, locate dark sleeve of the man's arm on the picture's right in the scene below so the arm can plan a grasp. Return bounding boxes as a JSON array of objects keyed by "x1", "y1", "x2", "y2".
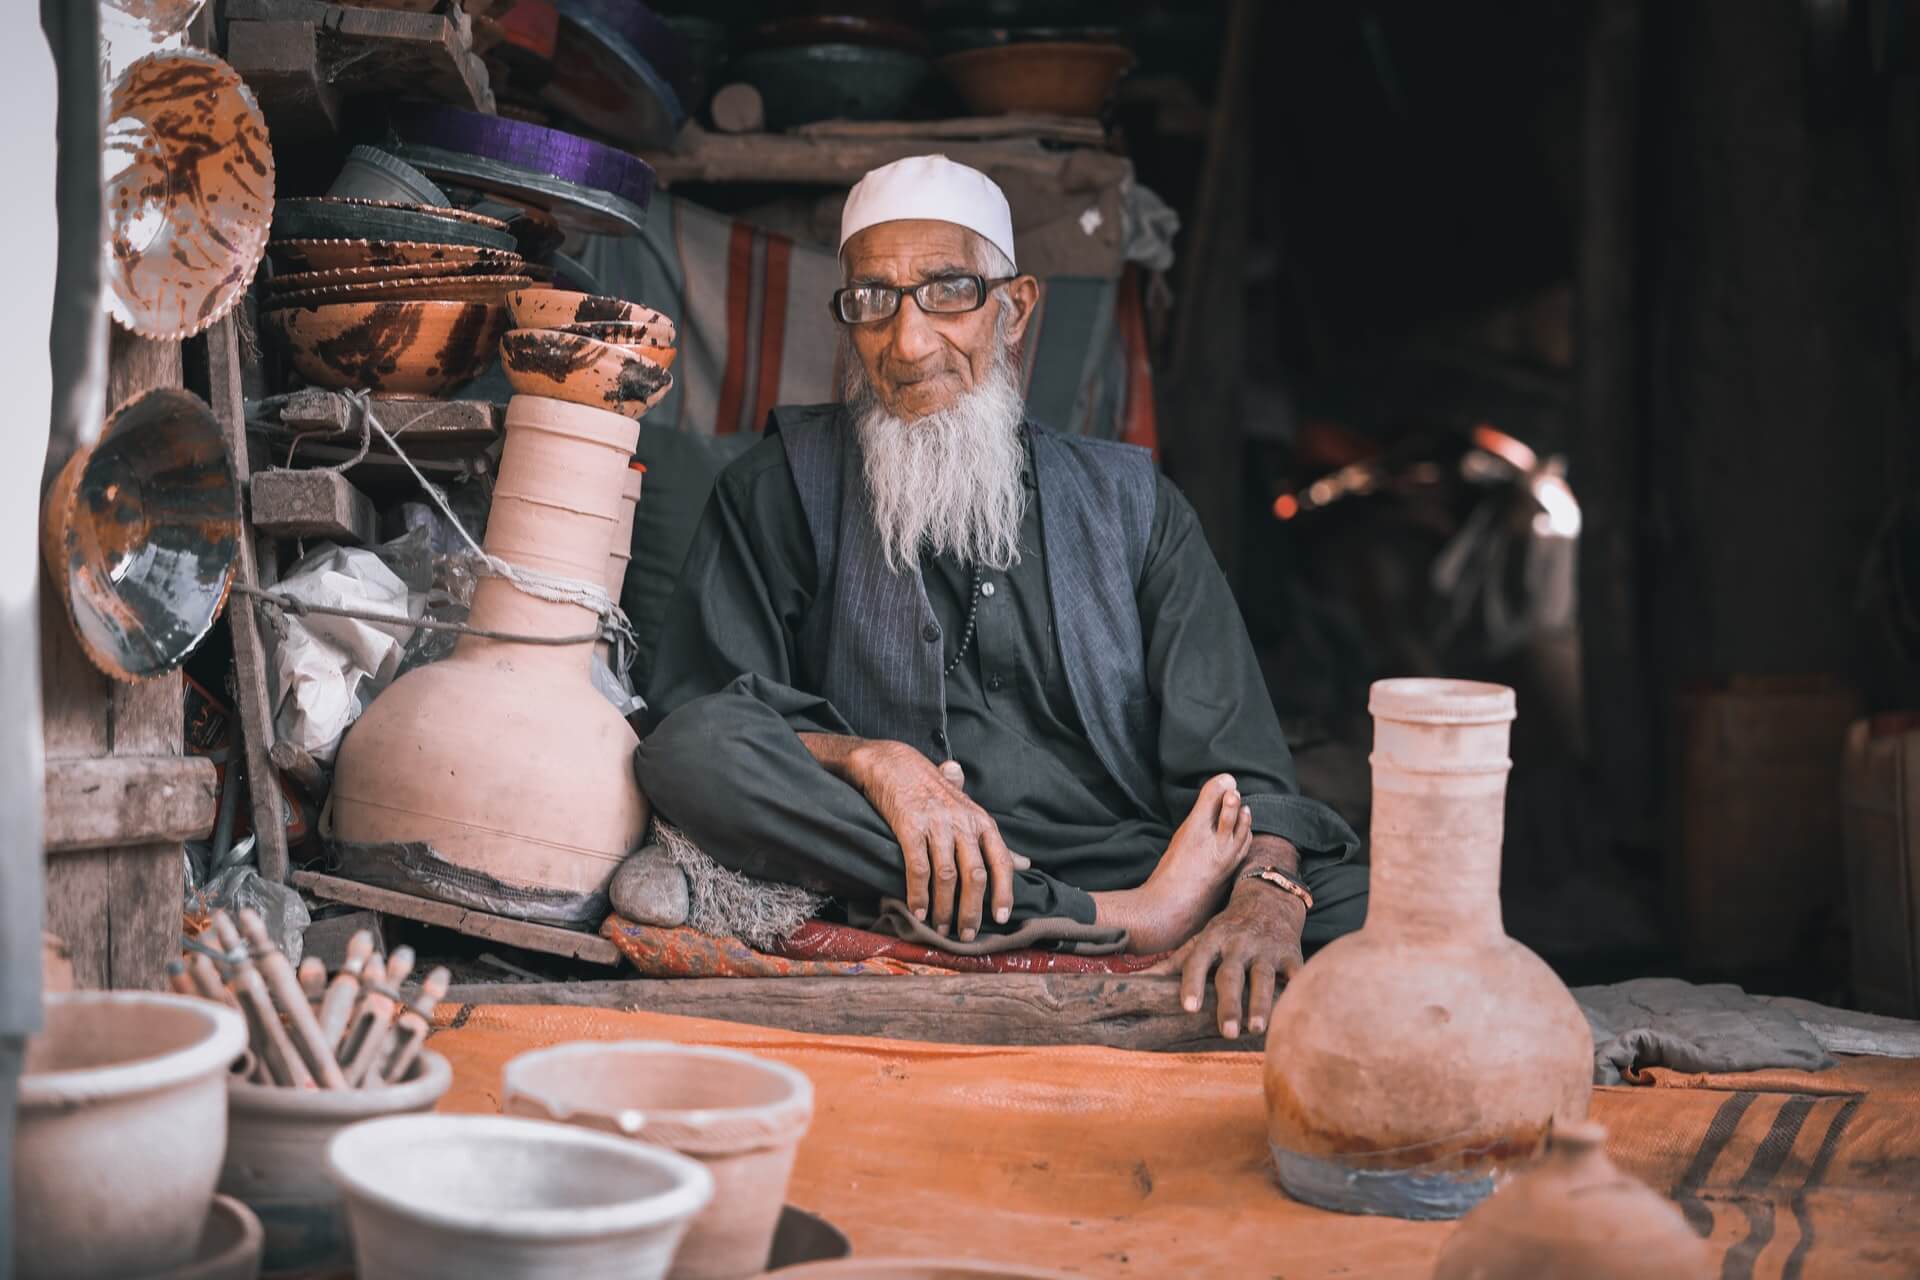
[{"x1": 1137, "y1": 478, "x2": 1359, "y2": 862}]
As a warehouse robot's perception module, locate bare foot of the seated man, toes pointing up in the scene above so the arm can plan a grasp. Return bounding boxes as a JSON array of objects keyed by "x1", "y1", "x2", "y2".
[{"x1": 1092, "y1": 773, "x2": 1254, "y2": 954}]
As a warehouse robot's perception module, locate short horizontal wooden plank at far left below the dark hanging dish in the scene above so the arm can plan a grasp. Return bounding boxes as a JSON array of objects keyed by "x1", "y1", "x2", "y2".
[{"x1": 46, "y1": 759, "x2": 217, "y2": 852}]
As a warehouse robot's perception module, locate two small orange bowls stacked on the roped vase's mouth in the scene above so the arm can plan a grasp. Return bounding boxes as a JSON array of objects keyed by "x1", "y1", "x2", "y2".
[{"x1": 499, "y1": 288, "x2": 676, "y2": 418}]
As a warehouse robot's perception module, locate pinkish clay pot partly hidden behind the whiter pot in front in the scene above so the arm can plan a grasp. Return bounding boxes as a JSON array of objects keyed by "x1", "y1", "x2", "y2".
[{"x1": 501, "y1": 1040, "x2": 814, "y2": 1280}]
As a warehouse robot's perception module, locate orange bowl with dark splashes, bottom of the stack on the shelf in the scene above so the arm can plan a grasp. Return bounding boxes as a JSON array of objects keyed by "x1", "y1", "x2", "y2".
[{"x1": 261, "y1": 301, "x2": 507, "y2": 395}]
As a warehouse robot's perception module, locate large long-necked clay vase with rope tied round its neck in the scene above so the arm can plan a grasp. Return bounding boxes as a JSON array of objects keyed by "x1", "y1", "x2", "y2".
[{"x1": 332, "y1": 395, "x2": 647, "y2": 913}]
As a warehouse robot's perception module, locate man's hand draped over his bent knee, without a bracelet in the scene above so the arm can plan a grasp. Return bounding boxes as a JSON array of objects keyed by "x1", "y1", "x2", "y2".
[{"x1": 829, "y1": 735, "x2": 1033, "y2": 942}]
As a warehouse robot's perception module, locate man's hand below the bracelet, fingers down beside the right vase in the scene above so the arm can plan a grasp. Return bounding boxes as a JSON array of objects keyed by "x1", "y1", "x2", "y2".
[{"x1": 1167, "y1": 879, "x2": 1308, "y2": 1040}]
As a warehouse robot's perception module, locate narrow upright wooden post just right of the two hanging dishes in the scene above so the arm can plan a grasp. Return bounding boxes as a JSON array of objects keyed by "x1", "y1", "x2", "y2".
[{"x1": 205, "y1": 315, "x2": 288, "y2": 883}]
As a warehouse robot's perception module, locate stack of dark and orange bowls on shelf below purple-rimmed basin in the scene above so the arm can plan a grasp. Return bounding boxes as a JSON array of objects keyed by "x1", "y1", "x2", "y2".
[{"x1": 261, "y1": 196, "x2": 534, "y2": 399}]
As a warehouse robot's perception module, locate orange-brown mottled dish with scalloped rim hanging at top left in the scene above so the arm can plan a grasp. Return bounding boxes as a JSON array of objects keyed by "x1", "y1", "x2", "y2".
[{"x1": 102, "y1": 50, "x2": 273, "y2": 340}]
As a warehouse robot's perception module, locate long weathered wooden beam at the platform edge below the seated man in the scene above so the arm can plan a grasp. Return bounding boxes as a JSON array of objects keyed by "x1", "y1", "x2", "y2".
[{"x1": 442, "y1": 973, "x2": 1265, "y2": 1054}]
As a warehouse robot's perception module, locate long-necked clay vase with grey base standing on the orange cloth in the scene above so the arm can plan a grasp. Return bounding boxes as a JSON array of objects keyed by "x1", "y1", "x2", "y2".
[{"x1": 1265, "y1": 679, "x2": 1594, "y2": 1219}]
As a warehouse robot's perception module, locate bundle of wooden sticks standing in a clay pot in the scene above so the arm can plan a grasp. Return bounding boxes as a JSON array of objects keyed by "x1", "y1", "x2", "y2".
[{"x1": 167, "y1": 910, "x2": 453, "y2": 1088}]
